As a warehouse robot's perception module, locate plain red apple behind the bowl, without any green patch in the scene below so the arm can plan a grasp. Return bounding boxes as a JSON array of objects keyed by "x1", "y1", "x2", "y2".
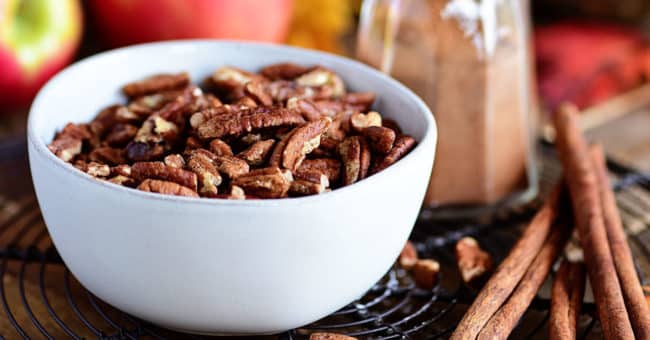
[{"x1": 89, "y1": 0, "x2": 293, "y2": 47}]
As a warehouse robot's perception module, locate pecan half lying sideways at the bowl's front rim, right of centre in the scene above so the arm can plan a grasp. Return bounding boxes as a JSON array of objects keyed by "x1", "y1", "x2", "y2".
[{"x1": 232, "y1": 167, "x2": 293, "y2": 198}]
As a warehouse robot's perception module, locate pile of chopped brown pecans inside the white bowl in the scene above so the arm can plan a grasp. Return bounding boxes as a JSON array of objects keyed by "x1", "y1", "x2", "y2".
[{"x1": 48, "y1": 63, "x2": 416, "y2": 199}]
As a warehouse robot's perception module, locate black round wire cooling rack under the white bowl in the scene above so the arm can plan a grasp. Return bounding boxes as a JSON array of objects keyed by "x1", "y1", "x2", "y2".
[{"x1": 0, "y1": 147, "x2": 650, "y2": 339}]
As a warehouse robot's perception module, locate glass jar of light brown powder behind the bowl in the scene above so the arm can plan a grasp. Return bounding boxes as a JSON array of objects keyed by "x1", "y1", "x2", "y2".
[{"x1": 357, "y1": 0, "x2": 537, "y2": 216}]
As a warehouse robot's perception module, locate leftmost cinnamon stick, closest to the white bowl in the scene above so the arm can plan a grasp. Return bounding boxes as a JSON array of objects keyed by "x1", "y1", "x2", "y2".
[{"x1": 450, "y1": 183, "x2": 563, "y2": 340}]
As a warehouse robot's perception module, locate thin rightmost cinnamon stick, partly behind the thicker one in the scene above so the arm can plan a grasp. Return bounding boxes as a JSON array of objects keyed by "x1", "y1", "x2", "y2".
[{"x1": 589, "y1": 145, "x2": 650, "y2": 340}]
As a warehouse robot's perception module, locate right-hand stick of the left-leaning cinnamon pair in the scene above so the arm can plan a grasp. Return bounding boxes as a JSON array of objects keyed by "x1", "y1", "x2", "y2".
[{"x1": 478, "y1": 223, "x2": 571, "y2": 340}]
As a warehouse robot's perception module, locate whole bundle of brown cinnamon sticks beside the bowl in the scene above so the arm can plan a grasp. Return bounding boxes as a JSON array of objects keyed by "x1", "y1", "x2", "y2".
[{"x1": 451, "y1": 104, "x2": 650, "y2": 340}]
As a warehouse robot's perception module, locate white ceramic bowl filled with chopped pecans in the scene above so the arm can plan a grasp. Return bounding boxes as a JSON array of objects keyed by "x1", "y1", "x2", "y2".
[{"x1": 28, "y1": 40, "x2": 436, "y2": 334}]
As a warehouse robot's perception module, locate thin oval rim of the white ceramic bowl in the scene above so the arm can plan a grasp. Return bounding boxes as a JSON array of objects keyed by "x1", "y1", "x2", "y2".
[{"x1": 27, "y1": 39, "x2": 437, "y2": 207}]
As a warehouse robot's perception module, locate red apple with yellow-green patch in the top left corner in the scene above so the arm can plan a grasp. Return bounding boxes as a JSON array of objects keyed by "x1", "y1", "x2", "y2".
[{"x1": 0, "y1": 0, "x2": 82, "y2": 113}]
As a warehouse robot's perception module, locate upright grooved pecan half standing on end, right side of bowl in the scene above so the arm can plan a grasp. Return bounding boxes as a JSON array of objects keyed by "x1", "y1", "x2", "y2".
[{"x1": 338, "y1": 136, "x2": 370, "y2": 185}]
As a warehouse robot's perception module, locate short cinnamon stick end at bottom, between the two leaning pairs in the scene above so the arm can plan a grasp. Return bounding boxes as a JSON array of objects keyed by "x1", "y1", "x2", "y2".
[{"x1": 549, "y1": 259, "x2": 586, "y2": 340}]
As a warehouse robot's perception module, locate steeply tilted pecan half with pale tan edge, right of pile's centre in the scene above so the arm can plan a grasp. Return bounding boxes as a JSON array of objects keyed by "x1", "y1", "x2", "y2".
[{"x1": 282, "y1": 117, "x2": 332, "y2": 170}]
